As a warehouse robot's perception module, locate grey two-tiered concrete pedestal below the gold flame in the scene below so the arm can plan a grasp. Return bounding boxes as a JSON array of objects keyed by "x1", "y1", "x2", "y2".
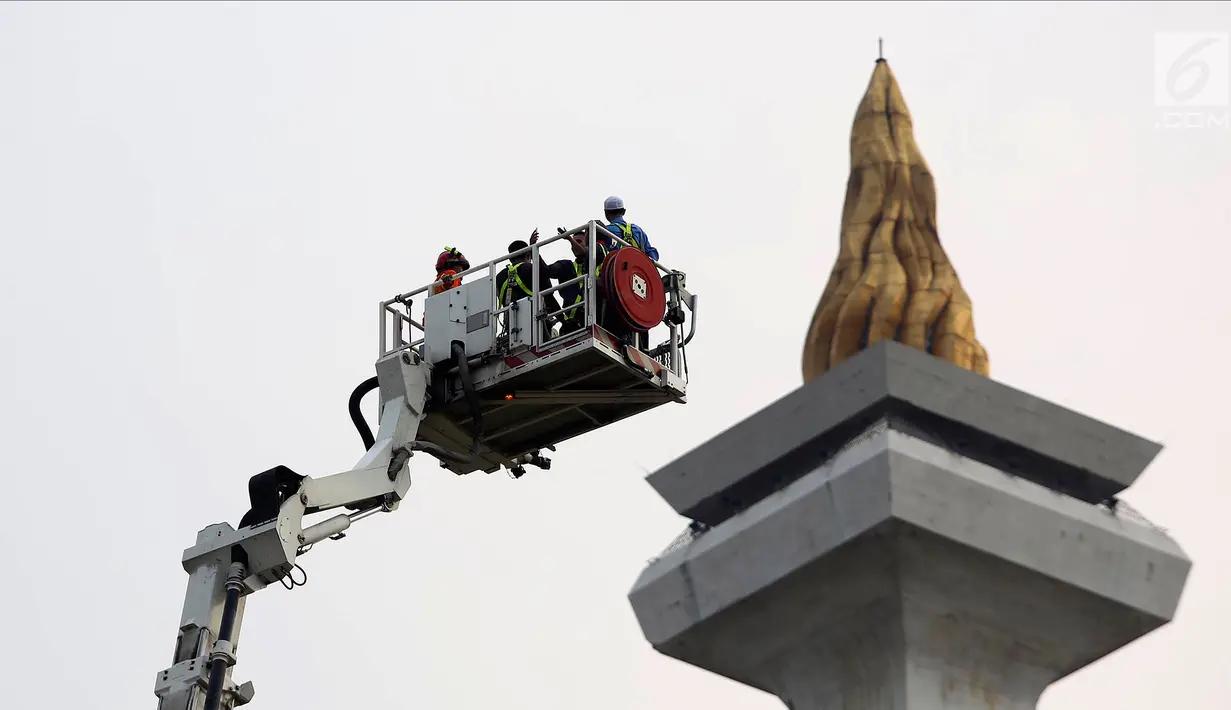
[{"x1": 630, "y1": 343, "x2": 1190, "y2": 710}]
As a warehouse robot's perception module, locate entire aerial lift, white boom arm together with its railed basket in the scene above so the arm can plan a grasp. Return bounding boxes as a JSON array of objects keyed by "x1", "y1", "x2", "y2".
[{"x1": 154, "y1": 221, "x2": 697, "y2": 710}]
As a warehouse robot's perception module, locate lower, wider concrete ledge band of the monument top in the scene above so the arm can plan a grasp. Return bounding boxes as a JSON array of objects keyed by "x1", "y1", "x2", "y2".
[{"x1": 629, "y1": 423, "x2": 1192, "y2": 652}]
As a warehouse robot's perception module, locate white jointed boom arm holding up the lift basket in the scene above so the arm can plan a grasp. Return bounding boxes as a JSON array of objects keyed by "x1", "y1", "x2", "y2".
[{"x1": 154, "y1": 351, "x2": 431, "y2": 710}]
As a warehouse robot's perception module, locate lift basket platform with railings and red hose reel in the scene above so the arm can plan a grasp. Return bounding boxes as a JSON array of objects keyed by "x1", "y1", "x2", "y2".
[{"x1": 380, "y1": 223, "x2": 697, "y2": 474}]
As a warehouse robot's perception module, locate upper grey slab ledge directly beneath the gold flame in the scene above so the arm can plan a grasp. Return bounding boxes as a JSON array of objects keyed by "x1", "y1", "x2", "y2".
[{"x1": 648, "y1": 341, "x2": 1162, "y2": 525}]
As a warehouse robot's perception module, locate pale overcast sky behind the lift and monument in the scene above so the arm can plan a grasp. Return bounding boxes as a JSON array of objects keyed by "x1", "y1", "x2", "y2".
[{"x1": 0, "y1": 2, "x2": 1231, "y2": 710}]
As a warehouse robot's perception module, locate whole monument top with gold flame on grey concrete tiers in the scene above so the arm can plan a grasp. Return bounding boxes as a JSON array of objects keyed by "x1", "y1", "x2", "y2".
[{"x1": 629, "y1": 60, "x2": 1192, "y2": 710}]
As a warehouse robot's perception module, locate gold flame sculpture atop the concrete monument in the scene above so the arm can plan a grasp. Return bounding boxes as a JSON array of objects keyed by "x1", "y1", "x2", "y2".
[{"x1": 804, "y1": 59, "x2": 988, "y2": 383}]
